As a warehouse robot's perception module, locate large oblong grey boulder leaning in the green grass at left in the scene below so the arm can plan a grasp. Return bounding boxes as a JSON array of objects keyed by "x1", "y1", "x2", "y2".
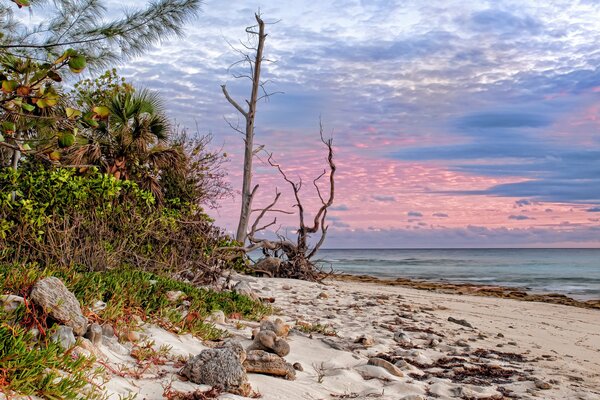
[{"x1": 31, "y1": 276, "x2": 87, "y2": 336}]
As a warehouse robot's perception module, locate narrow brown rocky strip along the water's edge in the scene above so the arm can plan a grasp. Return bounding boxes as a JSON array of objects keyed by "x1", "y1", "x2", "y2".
[{"x1": 326, "y1": 273, "x2": 600, "y2": 310}]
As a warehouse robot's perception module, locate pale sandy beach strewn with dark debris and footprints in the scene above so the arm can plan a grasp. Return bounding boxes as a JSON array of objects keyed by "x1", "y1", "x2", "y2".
[{"x1": 97, "y1": 277, "x2": 600, "y2": 400}]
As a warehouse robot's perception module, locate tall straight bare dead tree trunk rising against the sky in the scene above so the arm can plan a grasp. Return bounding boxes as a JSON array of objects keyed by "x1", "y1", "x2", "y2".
[{"x1": 221, "y1": 14, "x2": 267, "y2": 243}]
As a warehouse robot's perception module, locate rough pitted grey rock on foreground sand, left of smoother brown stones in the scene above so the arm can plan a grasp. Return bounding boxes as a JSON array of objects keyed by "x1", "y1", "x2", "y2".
[{"x1": 180, "y1": 341, "x2": 252, "y2": 396}]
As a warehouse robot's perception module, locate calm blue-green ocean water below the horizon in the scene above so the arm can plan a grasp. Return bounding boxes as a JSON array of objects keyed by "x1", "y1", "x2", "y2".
[{"x1": 317, "y1": 249, "x2": 600, "y2": 300}]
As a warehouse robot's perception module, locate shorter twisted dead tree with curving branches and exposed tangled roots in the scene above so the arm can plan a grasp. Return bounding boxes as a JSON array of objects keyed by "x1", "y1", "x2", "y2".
[{"x1": 224, "y1": 125, "x2": 336, "y2": 281}]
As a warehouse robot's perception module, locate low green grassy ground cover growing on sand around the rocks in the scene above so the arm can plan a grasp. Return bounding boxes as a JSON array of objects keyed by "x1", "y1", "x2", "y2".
[{"x1": 0, "y1": 265, "x2": 271, "y2": 399}]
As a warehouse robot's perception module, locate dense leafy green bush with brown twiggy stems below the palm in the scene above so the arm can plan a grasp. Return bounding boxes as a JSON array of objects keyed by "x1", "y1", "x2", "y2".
[{"x1": 0, "y1": 169, "x2": 239, "y2": 281}]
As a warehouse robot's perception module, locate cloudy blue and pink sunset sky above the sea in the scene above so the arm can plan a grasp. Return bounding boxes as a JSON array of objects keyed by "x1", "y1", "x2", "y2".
[{"x1": 78, "y1": 0, "x2": 600, "y2": 247}]
